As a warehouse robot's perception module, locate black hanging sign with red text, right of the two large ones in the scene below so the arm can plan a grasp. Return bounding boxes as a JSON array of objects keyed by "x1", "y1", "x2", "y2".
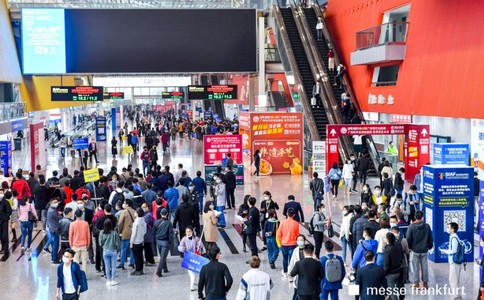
[{"x1": 188, "y1": 85, "x2": 237, "y2": 100}]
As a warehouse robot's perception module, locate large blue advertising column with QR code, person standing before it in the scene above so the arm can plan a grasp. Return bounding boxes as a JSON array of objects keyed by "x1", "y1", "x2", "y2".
[{"x1": 423, "y1": 166, "x2": 474, "y2": 263}]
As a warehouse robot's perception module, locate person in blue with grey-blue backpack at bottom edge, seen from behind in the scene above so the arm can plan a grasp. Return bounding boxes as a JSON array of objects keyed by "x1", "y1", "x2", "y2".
[{"x1": 320, "y1": 241, "x2": 346, "y2": 300}]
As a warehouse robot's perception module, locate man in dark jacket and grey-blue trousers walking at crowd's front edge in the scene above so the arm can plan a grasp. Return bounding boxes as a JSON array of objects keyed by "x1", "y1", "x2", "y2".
[{"x1": 153, "y1": 208, "x2": 174, "y2": 277}]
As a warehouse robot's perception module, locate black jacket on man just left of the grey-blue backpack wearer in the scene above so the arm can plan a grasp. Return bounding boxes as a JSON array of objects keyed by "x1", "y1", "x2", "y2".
[{"x1": 291, "y1": 257, "x2": 324, "y2": 296}]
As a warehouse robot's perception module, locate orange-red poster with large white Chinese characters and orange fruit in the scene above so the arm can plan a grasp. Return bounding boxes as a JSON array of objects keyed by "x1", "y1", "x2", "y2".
[{"x1": 252, "y1": 139, "x2": 303, "y2": 176}]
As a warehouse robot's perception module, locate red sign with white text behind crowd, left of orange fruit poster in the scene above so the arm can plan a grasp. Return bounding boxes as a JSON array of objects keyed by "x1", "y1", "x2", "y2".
[{"x1": 203, "y1": 134, "x2": 243, "y2": 165}]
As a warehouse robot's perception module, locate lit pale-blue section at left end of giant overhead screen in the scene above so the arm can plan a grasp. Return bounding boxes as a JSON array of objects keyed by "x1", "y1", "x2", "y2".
[{"x1": 22, "y1": 9, "x2": 66, "y2": 74}]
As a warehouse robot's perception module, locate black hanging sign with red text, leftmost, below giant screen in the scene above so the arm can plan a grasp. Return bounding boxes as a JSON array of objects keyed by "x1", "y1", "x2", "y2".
[{"x1": 50, "y1": 86, "x2": 104, "y2": 101}]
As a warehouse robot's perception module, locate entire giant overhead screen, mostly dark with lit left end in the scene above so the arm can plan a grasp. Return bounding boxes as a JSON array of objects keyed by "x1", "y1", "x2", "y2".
[{"x1": 22, "y1": 9, "x2": 257, "y2": 74}]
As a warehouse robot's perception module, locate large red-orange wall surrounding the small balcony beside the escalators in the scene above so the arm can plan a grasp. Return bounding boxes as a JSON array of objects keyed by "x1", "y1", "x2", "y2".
[{"x1": 326, "y1": 0, "x2": 484, "y2": 119}]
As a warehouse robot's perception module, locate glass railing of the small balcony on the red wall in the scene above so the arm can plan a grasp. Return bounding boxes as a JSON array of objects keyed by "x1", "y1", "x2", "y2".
[{"x1": 356, "y1": 22, "x2": 409, "y2": 50}]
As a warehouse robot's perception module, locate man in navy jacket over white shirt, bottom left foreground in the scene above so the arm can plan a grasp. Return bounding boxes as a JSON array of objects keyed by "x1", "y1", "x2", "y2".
[{"x1": 56, "y1": 249, "x2": 82, "y2": 300}]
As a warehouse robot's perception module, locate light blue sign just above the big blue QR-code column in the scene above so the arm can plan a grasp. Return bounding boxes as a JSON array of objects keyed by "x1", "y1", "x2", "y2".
[{"x1": 434, "y1": 143, "x2": 470, "y2": 166}]
